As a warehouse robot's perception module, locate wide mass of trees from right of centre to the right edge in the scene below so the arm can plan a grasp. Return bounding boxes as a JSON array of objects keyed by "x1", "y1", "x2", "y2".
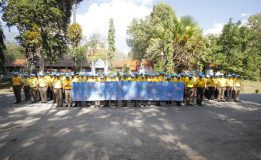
[{"x1": 127, "y1": 3, "x2": 261, "y2": 79}]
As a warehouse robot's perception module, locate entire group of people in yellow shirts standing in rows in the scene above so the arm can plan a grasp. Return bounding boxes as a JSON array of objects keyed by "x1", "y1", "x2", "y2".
[{"x1": 12, "y1": 72, "x2": 241, "y2": 107}]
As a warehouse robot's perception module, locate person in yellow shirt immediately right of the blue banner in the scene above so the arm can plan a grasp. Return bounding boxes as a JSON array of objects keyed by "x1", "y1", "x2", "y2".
[{"x1": 185, "y1": 75, "x2": 195, "y2": 105}]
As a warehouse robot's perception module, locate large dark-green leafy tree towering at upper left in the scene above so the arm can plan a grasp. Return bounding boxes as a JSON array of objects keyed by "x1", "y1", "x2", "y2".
[{"x1": 2, "y1": 0, "x2": 79, "y2": 73}]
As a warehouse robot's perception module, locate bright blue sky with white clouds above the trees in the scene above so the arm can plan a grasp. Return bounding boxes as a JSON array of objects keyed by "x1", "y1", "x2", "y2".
[{"x1": 3, "y1": 0, "x2": 261, "y2": 53}]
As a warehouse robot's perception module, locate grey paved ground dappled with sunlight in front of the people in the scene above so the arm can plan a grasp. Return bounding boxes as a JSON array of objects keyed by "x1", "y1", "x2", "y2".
[{"x1": 0, "y1": 93, "x2": 261, "y2": 160}]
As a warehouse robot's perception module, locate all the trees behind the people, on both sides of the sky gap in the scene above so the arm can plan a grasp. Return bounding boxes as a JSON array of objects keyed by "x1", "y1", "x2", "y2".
[{"x1": 0, "y1": 0, "x2": 261, "y2": 79}]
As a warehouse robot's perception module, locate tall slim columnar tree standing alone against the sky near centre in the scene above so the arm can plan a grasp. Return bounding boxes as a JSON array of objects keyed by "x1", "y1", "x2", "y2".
[{"x1": 108, "y1": 18, "x2": 116, "y2": 71}]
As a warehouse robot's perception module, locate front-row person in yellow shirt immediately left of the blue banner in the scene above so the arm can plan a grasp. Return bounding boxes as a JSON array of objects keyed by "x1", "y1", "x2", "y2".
[{"x1": 63, "y1": 73, "x2": 72, "y2": 107}]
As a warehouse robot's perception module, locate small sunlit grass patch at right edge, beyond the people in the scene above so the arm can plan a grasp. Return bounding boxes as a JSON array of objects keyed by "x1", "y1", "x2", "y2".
[{"x1": 242, "y1": 80, "x2": 261, "y2": 94}]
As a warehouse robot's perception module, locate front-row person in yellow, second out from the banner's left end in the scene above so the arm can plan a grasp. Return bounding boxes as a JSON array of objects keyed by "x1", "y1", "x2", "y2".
[{"x1": 53, "y1": 73, "x2": 63, "y2": 107}]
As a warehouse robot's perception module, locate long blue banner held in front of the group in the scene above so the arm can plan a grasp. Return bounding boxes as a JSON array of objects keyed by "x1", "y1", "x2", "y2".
[{"x1": 72, "y1": 82, "x2": 184, "y2": 101}]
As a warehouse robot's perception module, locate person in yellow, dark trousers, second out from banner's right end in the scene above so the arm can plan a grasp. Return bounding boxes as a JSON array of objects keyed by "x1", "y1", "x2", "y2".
[{"x1": 195, "y1": 74, "x2": 206, "y2": 106}]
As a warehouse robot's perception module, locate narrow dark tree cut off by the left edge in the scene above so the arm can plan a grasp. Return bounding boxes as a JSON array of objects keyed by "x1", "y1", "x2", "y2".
[{"x1": 0, "y1": 24, "x2": 6, "y2": 74}]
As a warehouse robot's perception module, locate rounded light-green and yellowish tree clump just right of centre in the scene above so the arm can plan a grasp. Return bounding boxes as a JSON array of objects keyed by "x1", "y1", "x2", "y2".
[{"x1": 127, "y1": 3, "x2": 206, "y2": 73}]
